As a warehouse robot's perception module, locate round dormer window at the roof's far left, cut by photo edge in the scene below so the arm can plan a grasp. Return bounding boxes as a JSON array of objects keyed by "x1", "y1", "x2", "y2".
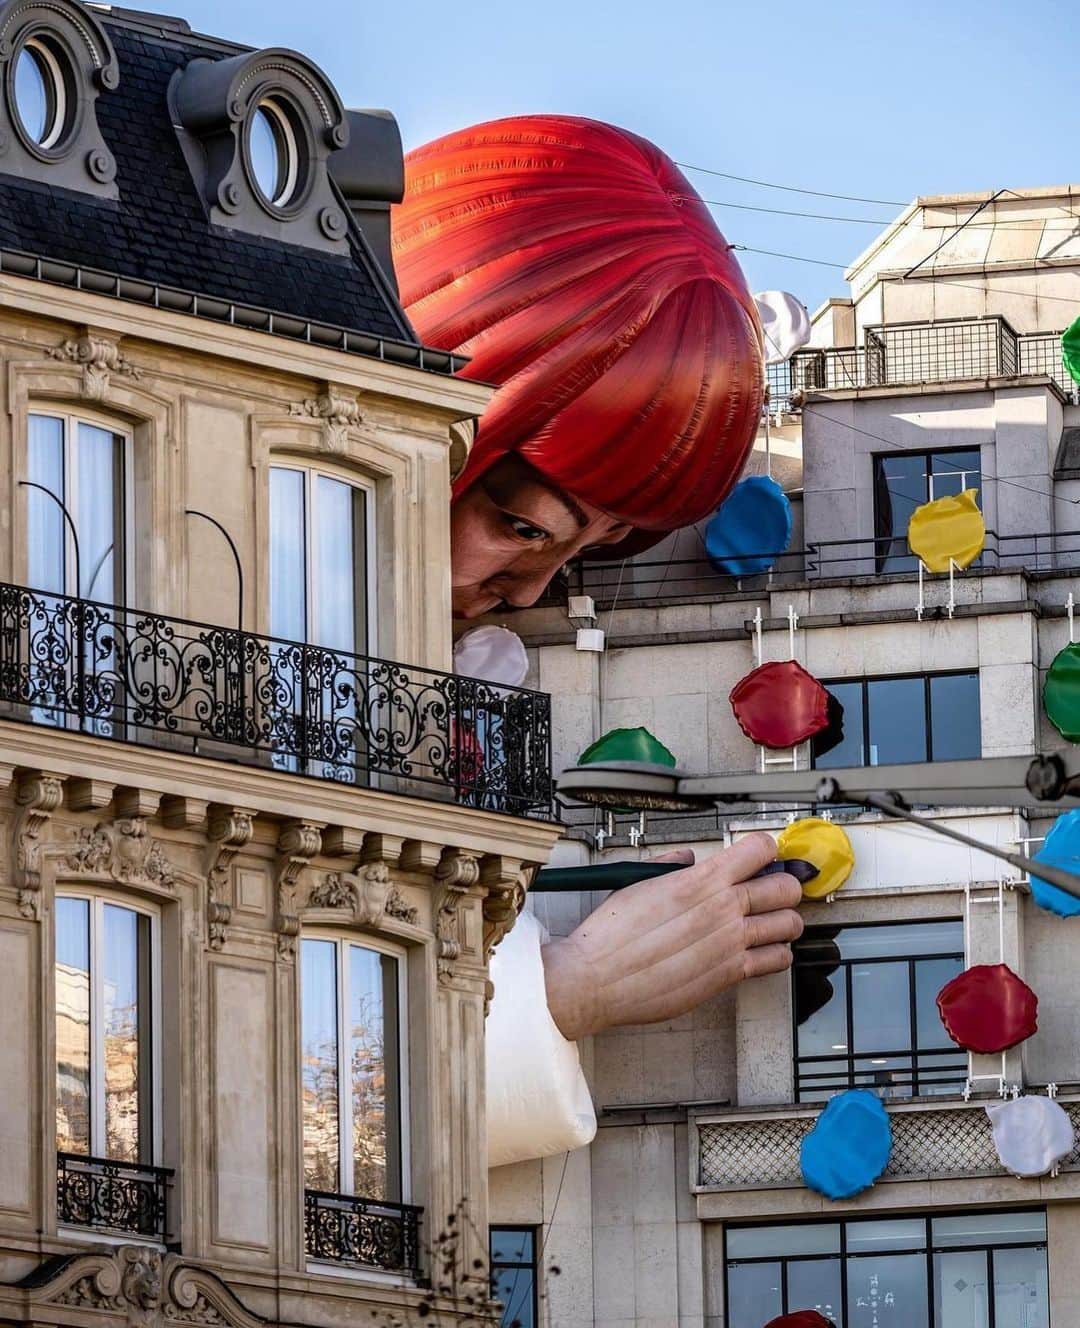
[{"x1": 0, "y1": 0, "x2": 120, "y2": 198}]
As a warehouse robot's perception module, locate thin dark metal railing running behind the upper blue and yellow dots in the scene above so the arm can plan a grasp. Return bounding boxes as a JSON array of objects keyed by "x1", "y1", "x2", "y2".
[{"x1": 539, "y1": 530, "x2": 1080, "y2": 610}]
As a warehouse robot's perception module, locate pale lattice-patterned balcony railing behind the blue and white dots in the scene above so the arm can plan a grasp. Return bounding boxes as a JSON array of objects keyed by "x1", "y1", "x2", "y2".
[{"x1": 693, "y1": 1094, "x2": 1080, "y2": 1191}]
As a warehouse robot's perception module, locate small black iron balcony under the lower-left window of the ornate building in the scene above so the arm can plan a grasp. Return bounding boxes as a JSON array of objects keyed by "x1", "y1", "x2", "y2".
[{"x1": 56, "y1": 1153, "x2": 173, "y2": 1243}]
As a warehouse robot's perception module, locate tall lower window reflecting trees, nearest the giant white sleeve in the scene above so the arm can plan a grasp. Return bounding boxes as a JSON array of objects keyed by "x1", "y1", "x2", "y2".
[{"x1": 300, "y1": 938, "x2": 404, "y2": 1203}]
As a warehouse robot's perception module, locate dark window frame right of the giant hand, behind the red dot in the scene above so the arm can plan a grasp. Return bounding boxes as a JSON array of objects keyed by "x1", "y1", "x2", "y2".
[{"x1": 790, "y1": 918, "x2": 968, "y2": 1104}]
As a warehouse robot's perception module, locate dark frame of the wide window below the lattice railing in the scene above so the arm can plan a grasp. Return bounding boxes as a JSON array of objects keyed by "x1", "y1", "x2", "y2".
[{"x1": 724, "y1": 1206, "x2": 1052, "y2": 1328}]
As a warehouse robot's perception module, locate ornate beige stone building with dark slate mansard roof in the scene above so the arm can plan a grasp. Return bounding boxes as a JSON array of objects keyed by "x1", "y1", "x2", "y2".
[{"x1": 0, "y1": 0, "x2": 557, "y2": 1328}]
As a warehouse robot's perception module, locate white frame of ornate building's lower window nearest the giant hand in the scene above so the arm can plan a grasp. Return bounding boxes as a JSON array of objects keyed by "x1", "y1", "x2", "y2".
[{"x1": 296, "y1": 926, "x2": 413, "y2": 1206}]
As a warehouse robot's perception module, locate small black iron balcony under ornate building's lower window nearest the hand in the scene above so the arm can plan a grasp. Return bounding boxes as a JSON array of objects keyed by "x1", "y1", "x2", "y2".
[{"x1": 304, "y1": 1190, "x2": 424, "y2": 1276}]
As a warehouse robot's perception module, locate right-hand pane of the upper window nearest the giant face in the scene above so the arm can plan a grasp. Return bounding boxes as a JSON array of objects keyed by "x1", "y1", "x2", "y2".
[{"x1": 312, "y1": 475, "x2": 365, "y2": 653}]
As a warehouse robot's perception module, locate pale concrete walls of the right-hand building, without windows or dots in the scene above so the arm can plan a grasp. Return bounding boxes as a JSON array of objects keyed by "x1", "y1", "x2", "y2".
[{"x1": 492, "y1": 190, "x2": 1080, "y2": 1328}]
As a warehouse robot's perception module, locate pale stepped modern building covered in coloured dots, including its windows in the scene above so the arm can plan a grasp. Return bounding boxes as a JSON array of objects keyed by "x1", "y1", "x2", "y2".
[{"x1": 492, "y1": 187, "x2": 1080, "y2": 1328}]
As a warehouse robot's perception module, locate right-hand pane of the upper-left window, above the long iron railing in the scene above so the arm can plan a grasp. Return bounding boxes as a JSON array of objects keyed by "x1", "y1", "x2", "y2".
[{"x1": 74, "y1": 424, "x2": 124, "y2": 604}]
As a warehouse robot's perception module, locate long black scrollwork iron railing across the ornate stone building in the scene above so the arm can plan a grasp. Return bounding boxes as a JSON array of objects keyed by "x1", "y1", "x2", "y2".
[{"x1": 0, "y1": 583, "x2": 551, "y2": 817}]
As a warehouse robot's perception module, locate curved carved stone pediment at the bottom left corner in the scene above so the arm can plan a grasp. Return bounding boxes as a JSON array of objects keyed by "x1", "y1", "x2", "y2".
[{"x1": 8, "y1": 1246, "x2": 267, "y2": 1328}]
